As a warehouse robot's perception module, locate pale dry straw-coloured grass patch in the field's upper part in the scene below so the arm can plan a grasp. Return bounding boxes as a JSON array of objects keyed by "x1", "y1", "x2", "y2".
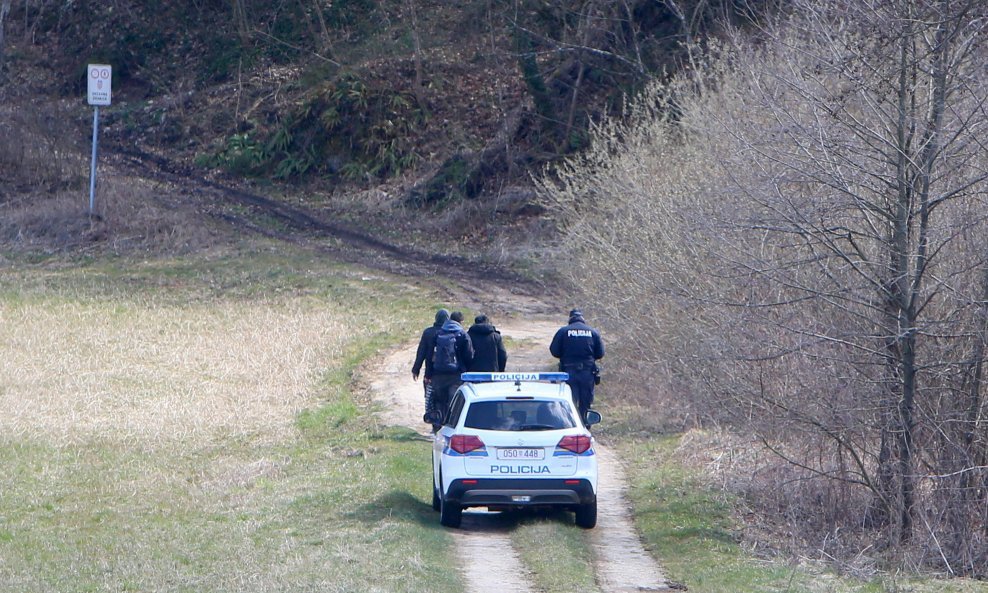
[{"x1": 0, "y1": 300, "x2": 352, "y2": 446}]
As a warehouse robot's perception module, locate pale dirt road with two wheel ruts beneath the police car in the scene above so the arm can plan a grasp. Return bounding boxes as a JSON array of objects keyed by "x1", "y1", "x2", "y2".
[{"x1": 370, "y1": 310, "x2": 670, "y2": 593}]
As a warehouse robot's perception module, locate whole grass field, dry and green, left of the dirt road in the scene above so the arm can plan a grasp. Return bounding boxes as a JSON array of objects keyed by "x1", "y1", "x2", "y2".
[{"x1": 0, "y1": 249, "x2": 461, "y2": 593}]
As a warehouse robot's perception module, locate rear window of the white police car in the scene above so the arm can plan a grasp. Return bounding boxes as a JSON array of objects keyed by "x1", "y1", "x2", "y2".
[{"x1": 464, "y1": 400, "x2": 576, "y2": 430}]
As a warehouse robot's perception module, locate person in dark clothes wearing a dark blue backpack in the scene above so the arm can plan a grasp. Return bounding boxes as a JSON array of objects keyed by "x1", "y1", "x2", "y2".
[{"x1": 430, "y1": 311, "x2": 473, "y2": 432}]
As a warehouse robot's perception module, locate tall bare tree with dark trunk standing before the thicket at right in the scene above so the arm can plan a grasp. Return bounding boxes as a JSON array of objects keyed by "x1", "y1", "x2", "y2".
[{"x1": 716, "y1": 0, "x2": 988, "y2": 542}]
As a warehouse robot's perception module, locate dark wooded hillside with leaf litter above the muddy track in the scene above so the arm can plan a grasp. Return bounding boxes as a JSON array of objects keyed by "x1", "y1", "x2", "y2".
[{"x1": 0, "y1": 0, "x2": 745, "y2": 215}]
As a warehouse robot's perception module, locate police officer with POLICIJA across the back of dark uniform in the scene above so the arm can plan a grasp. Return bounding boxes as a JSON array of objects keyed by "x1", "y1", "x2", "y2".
[{"x1": 549, "y1": 309, "x2": 604, "y2": 423}]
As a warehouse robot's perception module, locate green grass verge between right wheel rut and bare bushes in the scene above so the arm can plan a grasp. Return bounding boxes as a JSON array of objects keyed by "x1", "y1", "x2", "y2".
[{"x1": 614, "y1": 430, "x2": 988, "y2": 593}]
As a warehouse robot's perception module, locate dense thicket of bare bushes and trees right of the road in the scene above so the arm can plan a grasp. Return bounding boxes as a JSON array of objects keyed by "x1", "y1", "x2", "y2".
[{"x1": 544, "y1": 0, "x2": 988, "y2": 576}]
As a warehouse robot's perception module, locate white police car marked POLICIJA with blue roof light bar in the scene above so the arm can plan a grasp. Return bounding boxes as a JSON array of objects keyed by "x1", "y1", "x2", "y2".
[{"x1": 432, "y1": 373, "x2": 600, "y2": 529}]
